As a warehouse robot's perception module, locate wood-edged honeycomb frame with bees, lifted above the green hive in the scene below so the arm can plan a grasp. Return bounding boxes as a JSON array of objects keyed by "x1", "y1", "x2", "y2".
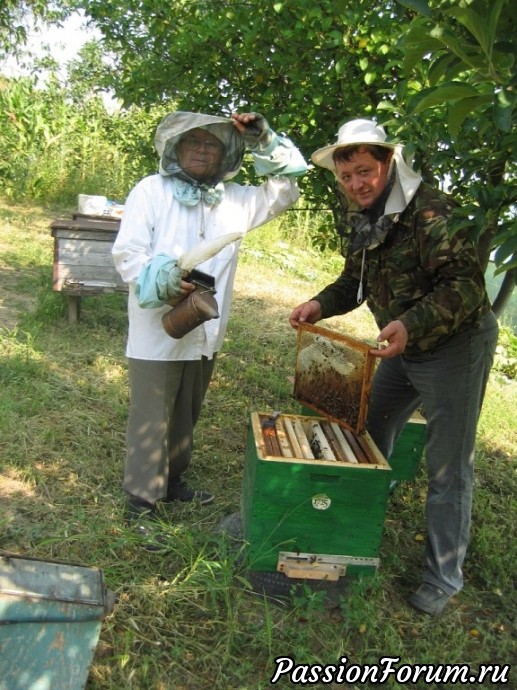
[{"x1": 294, "y1": 324, "x2": 375, "y2": 433}]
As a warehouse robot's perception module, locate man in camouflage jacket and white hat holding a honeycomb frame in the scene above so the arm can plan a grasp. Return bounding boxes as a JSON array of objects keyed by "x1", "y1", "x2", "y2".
[{"x1": 290, "y1": 120, "x2": 498, "y2": 615}]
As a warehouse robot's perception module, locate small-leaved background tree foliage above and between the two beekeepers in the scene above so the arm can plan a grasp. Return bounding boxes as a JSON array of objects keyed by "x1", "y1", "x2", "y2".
[{"x1": 79, "y1": 0, "x2": 416, "y2": 249}]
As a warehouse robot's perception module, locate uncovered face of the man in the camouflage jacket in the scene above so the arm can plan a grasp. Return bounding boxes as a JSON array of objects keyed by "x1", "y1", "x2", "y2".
[{"x1": 335, "y1": 149, "x2": 391, "y2": 208}]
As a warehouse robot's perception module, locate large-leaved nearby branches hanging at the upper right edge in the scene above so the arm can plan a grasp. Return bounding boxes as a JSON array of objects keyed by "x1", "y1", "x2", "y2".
[{"x1": 394, "y1": 0, "x2": 517, "y2": 294}]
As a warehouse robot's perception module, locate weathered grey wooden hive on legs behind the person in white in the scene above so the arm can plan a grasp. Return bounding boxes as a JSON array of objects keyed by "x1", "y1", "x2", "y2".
[{"x1": 50, "y1": 213, "x2": 128, "y2": 323}]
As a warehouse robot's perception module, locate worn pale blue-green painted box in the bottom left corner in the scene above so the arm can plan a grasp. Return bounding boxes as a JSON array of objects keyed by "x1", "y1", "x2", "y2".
[{"x1": 0, "y1": 557, "x2": 112, "y2": 690}]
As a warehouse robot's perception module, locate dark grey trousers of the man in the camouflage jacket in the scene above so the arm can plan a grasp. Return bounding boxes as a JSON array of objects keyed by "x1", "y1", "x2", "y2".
[{"x1": 366, "y1": 313, "x2": 498, "y2": 595}]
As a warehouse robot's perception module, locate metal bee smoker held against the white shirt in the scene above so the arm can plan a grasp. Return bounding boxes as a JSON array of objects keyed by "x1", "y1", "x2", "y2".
[{"x1": 162, "y1": 269, "x2": 219, "y2": 339}]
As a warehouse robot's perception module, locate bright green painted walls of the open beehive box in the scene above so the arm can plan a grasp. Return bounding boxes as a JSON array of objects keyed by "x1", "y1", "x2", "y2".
[{"x1": 242, "y1": 416, "x2": 391, "y2": 575}]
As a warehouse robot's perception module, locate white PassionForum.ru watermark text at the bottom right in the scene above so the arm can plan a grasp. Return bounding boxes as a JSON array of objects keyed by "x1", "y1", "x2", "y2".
[{"x1": 269, "y1": 656, "x2": 511, "y2": 686}]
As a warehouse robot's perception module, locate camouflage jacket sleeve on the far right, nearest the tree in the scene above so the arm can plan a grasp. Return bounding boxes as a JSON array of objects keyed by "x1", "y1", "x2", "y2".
[{"x1": 398, "y1": 205, "x2": 487, "y2": 351}]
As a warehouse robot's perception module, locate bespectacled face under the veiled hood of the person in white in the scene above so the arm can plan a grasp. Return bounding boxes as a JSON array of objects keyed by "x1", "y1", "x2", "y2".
[{"x1": 177, "y1": 128, "x2": 224, "y2": 182}]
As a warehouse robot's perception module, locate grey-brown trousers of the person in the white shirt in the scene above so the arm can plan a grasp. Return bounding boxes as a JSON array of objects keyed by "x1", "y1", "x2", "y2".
[{"x1": 123, "y1": 356, "x2": 215, "y2": 504}]
